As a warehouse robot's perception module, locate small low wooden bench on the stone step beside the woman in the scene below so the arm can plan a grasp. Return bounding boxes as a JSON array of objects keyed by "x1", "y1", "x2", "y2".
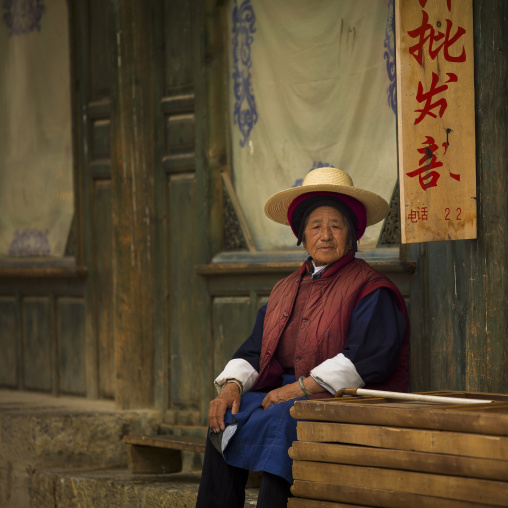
[{"x1": 123, "y1": 435, "x2": 206, "y2": 474}]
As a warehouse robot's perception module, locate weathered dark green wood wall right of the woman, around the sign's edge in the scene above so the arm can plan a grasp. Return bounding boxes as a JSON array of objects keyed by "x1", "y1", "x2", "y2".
[{"x1": 411, "y1": 0, "x2": 508, "y2": 393}]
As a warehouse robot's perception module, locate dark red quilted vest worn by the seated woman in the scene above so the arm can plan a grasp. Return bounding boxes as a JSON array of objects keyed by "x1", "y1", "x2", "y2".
[{"x1": 253, "y1": 252, "x2": 409, "y2": 398}]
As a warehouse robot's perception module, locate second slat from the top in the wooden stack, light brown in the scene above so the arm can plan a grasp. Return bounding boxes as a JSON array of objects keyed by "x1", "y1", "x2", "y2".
[{"x1": 297, "y1": 422, "x2": 508, "y2": 460}]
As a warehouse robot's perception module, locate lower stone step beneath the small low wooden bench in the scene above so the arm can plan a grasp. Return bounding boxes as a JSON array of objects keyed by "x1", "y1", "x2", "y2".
[{"x1": 32, "y1": 469, "x2": 258, "y2": 508}]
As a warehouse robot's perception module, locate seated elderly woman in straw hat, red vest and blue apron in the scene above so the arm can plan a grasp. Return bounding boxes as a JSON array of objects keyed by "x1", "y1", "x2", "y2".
[{"x1": 197, "y1": 168, "x2": 409, "y2": 508}]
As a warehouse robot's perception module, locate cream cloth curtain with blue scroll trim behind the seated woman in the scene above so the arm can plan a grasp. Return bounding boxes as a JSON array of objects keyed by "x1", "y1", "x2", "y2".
[{"x1": 228, "y1": 0, "x2": 397, "y2": 250}]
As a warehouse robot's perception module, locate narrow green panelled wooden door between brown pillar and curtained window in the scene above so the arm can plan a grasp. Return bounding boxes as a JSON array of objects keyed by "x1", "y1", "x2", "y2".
[{"x1": 157, "y1": 0, "x2": 214, "y2": 425}]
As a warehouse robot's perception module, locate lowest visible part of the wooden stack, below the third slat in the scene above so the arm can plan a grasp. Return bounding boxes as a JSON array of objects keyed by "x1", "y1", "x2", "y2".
[{"x1": 288, "y1": 480, "x2": 491, "y2": 508}]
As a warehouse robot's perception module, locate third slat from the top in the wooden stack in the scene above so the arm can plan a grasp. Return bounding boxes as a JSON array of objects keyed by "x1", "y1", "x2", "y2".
[{"x1": 289, "y1": 441, "x2": 508, "y2": 482}]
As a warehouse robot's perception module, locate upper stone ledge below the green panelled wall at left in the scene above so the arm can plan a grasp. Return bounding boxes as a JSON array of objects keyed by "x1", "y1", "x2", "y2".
[{"x1": 0, "y1": 390, "x2": 160, "y2": 508}]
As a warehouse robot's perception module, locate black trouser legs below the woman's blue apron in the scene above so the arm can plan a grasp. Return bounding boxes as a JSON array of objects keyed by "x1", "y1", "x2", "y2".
[{"x1": 196, "y1": 437, "x2": 291, "y2": 508}]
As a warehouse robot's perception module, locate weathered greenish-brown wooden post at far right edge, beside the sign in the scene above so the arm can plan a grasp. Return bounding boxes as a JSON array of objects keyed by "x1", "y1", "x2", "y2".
[{"x1": 465, "y1": 0, "x2": 508, "y2": 393}]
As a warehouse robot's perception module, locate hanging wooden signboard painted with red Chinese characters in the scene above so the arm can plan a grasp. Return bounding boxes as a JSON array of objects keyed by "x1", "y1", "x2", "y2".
[{"x1": 395, "y1": 0, "x2": 476, "y2": 243}]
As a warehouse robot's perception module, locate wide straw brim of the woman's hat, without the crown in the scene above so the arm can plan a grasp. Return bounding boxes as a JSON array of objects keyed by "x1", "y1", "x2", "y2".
[{"x1": 265, "y1": 184, "x2": 390, "y2": 226}]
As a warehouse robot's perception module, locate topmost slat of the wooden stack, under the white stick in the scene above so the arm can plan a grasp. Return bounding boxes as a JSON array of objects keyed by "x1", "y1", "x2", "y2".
[{"x1": 291, "y1": 392, "x2": 508, "y2": 436}]
